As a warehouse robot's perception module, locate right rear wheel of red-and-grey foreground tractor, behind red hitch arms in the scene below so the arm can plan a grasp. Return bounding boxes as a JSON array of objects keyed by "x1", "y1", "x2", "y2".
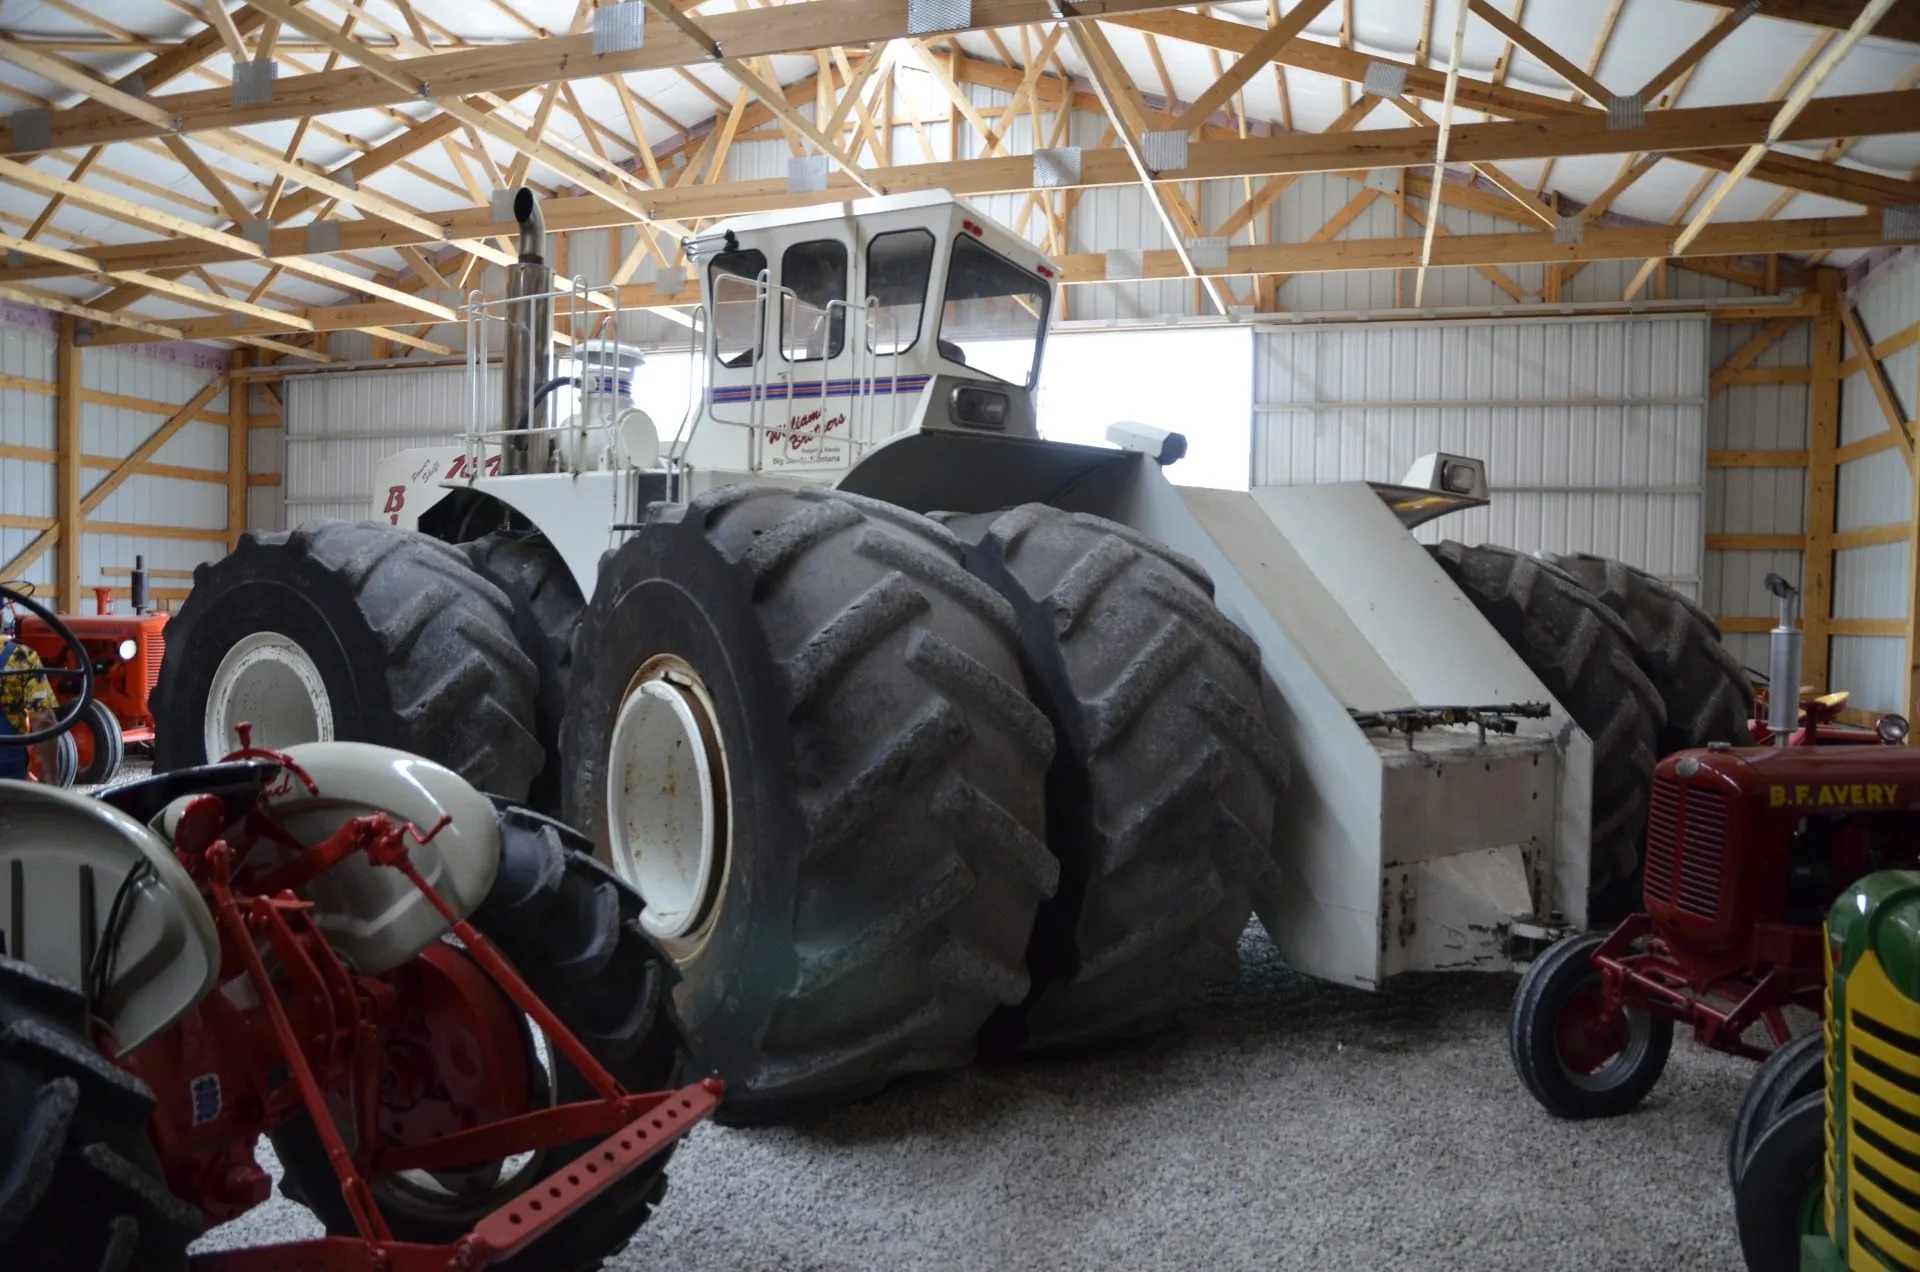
[{"x1": 273, "y1": 807, "x2": 680, "y2": 1272}]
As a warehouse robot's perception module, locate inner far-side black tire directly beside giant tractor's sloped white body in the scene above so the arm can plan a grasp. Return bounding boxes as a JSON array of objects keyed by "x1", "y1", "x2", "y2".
[{"x1": 1432, "y1": 540, "x2": 1667, "y2": 920}]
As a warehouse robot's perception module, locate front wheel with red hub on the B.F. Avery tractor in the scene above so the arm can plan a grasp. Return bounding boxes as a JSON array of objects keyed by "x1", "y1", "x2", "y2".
[{"x1": 1507, "y1": 932, "x2": 1674, "y2": 1118}]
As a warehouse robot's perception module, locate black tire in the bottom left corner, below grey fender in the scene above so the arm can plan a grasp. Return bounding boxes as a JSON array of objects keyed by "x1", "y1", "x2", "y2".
[{"x1": 0, "y1": 957, "x2": 200, "y2": 1272}]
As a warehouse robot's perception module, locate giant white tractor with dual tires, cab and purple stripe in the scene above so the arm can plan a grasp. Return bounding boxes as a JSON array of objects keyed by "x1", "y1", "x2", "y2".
[{"x1": 156, "y1": 192, "x2": 1751, "y2": 1120}]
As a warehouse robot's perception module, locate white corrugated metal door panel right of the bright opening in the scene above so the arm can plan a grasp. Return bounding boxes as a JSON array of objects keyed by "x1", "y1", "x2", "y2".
[{"x1": 1252, "y1": 315, "x2": 1707, "y2": 594}]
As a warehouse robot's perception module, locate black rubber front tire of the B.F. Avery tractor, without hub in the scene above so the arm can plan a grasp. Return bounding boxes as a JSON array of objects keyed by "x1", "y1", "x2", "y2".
[{"x1": 1507, "y1": 932, "x2": 1674, "y2": 1120}]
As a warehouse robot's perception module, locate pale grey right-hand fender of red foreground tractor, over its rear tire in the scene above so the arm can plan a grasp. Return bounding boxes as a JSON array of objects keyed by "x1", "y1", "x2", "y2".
[{"x1": 247, "y1": 742, "x2": 499, "y2": 974}]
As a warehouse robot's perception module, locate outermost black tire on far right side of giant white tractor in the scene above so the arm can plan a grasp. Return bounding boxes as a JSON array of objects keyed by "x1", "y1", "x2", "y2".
[{"x1": 1548, "y1": 551, "x2": 1753, "y2": 755}]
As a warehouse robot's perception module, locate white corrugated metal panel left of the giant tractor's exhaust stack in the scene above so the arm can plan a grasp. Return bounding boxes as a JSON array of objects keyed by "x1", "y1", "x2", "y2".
[{"x1": 284, "y1": 367, "x2": 491, "y2": 526}]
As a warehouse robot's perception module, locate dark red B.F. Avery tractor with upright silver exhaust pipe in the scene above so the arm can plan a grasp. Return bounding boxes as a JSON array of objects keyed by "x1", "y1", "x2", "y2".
[{"x1": 1509, "y1": 576, "x2": 1920, "y2": 1118}]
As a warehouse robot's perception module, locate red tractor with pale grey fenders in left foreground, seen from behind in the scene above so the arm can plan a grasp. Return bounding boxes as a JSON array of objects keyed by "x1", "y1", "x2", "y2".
[{"x1": 0, "y1": 588, "x2": 722, "y2": 1272}]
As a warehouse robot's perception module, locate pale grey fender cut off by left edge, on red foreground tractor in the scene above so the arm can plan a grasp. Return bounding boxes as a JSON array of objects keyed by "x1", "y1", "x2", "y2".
[{"x1": 0, "y1": 782, "x2": 221, "y2": 1053}]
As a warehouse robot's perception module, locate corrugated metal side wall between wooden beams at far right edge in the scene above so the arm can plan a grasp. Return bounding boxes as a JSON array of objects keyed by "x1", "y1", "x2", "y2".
[{"x1": 1832, "y1": 250, "x2": 1920, "y2": 711}]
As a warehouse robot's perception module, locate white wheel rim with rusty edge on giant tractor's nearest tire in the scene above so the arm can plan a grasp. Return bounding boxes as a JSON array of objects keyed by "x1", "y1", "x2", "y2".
[{"x1": 607, "y1": 655, "x2": 728, "y2": 953}]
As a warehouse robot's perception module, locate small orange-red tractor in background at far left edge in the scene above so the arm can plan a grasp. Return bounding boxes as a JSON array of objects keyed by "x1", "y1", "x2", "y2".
[{"x1": 13, "y1": 557, "x2": 167, "y2": 786}]
